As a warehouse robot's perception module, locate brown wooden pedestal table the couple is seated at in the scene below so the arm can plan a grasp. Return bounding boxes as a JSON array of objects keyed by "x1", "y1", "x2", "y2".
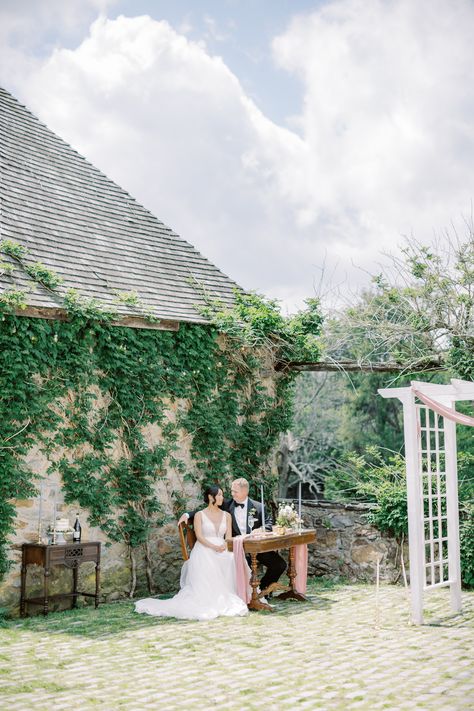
[{"x1": 227, "y1": 528, "x2": 316, "y2": 611}]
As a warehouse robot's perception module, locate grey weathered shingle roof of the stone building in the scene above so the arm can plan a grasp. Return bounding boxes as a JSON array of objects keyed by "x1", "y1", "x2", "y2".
[{"x1": 0, "y1": 89, "x2": 237, "y2": 322}]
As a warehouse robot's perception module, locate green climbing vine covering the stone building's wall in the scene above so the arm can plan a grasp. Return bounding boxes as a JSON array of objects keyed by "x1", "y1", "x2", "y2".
[{"x1": 0, "y1": 242, "x2": 320, "y2": 590}]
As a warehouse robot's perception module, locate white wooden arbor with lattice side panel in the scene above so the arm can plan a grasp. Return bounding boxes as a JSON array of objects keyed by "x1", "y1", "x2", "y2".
[{"x1": 378, "y1": 380, "x2": 474, "y2": 625}]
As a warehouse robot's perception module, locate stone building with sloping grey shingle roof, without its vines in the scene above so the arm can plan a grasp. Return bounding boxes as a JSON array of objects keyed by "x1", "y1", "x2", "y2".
[{"x1": 0, "y1": 89, "x2": 244, "y2": 608}]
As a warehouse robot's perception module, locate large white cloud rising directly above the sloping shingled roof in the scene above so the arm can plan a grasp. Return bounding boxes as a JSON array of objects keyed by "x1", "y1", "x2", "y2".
[{"x1": 12, "y1": 17, "x2": 310, "y2": 304}]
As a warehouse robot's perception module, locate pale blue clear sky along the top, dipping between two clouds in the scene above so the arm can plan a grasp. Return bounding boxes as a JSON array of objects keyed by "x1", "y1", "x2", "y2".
[{"x1": 4, "y1": 0, "x2": 325, "y2": 122}]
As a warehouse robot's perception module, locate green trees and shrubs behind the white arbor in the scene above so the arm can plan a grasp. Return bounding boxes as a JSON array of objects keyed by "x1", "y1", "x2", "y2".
[{"x1": 286, "y1": 230, "x2": 474, "y2": 585}]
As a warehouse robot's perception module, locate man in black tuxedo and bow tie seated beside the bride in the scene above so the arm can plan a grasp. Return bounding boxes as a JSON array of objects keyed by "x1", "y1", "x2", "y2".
[{"x1": 179, "y1": 478, "x2": 286, "y2": 590}]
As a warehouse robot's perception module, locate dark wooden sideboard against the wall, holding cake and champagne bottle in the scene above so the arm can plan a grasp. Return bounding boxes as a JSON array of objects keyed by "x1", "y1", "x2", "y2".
[{"x1": 20, "y1": 541, "x2": 100, "y2": 617}]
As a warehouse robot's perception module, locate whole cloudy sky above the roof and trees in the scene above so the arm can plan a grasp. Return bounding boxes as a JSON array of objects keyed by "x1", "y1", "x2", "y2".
[{"x1": 0, "y1": 0, "x2": 474, "y2": 312}]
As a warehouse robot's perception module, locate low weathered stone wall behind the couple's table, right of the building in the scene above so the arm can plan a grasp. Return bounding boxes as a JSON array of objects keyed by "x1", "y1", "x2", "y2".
[{"x1": 302, "y1": 501, "x2": 407, "y2": 582}]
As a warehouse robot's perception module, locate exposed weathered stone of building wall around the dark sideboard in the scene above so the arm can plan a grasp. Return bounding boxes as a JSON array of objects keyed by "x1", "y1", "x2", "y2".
[{"x1": 0, "y1": 412, "x2": 201, "y2": 614}]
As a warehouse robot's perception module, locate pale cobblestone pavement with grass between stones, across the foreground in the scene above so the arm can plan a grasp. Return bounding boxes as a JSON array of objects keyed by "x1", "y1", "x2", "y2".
[{"x1": 0, "y1": 585, "x2": 474, "y2": 711}]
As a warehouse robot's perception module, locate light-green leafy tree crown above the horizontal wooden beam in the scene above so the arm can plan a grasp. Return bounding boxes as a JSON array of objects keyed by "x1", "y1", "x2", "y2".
[{"x1": 325, "y1": 227, "x2": 474, "y2": 379}]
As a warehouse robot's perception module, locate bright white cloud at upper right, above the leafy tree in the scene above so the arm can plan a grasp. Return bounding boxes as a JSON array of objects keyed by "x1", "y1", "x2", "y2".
[{"x1": 273, "y1": 0, "x2": 474, "y2": 268}]
